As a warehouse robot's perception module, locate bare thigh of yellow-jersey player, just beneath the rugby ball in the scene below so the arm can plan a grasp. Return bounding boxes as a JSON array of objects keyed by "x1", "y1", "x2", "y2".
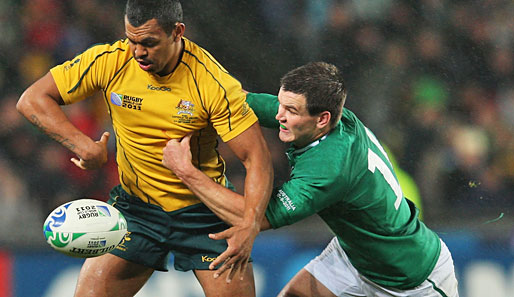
[{"x1": 75, "y1": 254, "x2": 153, "y2": 297}]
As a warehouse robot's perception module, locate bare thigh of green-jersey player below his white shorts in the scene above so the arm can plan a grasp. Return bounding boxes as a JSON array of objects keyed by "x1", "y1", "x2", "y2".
[{"x1": 278, "y1": 268, "x2": 336, "y2": 297}]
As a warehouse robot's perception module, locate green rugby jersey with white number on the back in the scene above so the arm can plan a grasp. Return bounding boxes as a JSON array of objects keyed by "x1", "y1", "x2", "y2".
[{"x1": 247, "y1": 93, "x2": 441, "y2": 289}]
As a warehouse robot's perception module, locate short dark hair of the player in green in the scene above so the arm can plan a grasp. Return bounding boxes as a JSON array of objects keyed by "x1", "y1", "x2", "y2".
[{"x1": 280, "y1": 62, "x2": 346, "y2": 128}]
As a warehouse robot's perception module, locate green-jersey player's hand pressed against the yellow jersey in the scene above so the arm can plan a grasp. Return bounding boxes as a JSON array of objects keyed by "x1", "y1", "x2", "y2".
[{"x1": 162, "y1": 133, "x2": 193, "y2": 178}]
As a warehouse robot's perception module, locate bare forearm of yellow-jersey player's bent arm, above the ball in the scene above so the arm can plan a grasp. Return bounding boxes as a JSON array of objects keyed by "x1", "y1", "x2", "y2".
[{"x1": 16, "y1": 86, "x2": 94, "y2": 158}]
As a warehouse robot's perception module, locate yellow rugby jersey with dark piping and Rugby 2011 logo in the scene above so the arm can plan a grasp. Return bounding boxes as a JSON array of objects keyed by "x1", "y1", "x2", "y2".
[{"x1": 50, "y1": 38, "x2": 257, "y2": 211}]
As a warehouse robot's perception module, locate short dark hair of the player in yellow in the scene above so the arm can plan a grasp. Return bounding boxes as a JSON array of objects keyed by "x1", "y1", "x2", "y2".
[{"x1": 125, "y1": 0, "x2": 182, "y2": 35}]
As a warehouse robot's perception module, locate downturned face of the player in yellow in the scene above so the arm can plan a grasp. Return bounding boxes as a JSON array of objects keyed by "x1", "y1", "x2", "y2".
[{"x1": 125, "y1": 16, "x2": 185, "y2": 76}]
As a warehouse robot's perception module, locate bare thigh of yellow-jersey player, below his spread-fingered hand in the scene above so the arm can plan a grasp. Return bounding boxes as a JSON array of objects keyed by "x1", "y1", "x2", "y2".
[{"x1": 194, "y1": 263, "x2": 255, "y2": 297}]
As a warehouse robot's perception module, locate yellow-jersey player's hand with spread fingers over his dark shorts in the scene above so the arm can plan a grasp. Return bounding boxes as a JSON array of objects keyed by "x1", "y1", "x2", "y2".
[{"x1": 209, "y1": 224, "x2": 259, "y2": 283}]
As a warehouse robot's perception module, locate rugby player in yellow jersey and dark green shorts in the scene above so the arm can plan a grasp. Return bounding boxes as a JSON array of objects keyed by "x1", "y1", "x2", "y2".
[{"x1": 17, "y1": 0, "x2": 273, "y2": 297}]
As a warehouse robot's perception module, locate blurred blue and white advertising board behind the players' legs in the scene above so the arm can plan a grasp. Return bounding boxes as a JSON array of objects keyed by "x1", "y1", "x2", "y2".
[{"x1": 0, "y1": 232, "x2": 514, "y2": 297}]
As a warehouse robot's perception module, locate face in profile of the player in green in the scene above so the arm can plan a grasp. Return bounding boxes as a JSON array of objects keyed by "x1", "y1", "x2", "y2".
[{"x1": 275, "y1": 89, "x2": 321, "y2": 147}]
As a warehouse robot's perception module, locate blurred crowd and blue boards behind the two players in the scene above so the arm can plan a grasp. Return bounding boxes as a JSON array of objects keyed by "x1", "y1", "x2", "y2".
[{"x1": 0, "y1": 0, "x2": 514, "y2": 297}]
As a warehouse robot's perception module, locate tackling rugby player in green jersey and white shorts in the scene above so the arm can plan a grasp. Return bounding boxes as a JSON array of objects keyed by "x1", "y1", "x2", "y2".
[{"x1": 163, "y1": 62, "x2": 458, "y2": 297}]
